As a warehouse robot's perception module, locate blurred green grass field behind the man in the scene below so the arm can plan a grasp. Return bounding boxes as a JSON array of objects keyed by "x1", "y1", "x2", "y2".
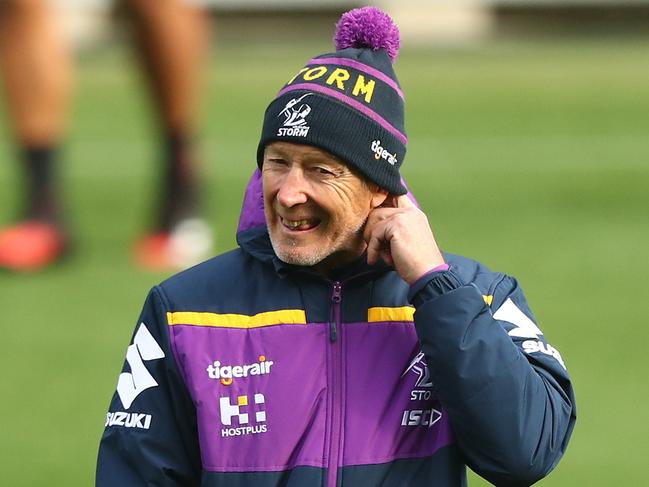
[{"x1": 0, "y1": 40, "x2": 649, "y2": 487}]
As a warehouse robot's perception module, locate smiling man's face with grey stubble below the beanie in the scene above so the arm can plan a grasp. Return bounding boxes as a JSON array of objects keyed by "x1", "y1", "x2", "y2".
[{"x1": 262, "y1": 142, "x2": 387, "y2": 273}]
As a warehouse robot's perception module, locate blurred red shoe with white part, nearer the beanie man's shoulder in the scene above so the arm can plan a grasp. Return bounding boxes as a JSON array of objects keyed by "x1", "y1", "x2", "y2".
[{"x1": 133, "y1": 219, "x2": 213, "y2": 272}]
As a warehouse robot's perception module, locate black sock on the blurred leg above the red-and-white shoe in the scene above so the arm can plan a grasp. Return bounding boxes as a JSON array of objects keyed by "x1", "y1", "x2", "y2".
[{"x1": 158, "y1": 134, "x2": 198, "y2": 230}]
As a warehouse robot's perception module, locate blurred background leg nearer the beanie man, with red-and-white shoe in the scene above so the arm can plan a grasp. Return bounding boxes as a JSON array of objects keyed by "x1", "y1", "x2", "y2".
[{"x1": 125, "y1": 0, "x2": 212, "y2": 269}]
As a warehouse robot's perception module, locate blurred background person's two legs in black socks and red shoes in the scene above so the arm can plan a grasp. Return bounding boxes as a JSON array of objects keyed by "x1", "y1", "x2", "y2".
[{"x1": 0, "y1": 0, "x2": 211, "y2": 272}]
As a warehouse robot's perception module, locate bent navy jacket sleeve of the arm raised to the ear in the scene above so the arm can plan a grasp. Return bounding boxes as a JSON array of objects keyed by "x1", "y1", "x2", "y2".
[{"x1": 410, "y1": 268, "x2": 576, "y2": 486}]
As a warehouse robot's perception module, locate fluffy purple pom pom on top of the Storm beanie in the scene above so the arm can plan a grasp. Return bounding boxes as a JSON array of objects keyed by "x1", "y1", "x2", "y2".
[{"x1": 334, "y1": 7, "x2": 400, "y2": 63}]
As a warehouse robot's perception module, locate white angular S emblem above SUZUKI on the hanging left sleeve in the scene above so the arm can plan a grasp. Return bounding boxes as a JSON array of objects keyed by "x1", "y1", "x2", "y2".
[{"x1": 117, "y1": 323, "x2": 165, "y2": 409}]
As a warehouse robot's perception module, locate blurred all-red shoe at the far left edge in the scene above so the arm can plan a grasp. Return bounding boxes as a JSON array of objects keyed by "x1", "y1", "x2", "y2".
[{"x1": 0, "y1": 220, "x2": 67, "y2": 272}]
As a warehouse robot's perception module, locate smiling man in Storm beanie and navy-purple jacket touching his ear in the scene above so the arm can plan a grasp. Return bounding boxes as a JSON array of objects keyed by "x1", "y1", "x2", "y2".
[{"x1": 97, "y1": 7, "x2": 575, "y2": 487}]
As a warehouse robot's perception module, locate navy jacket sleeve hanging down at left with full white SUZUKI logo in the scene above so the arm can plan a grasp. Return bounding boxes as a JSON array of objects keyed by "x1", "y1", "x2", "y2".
[{"x1": 96, "y1": 288, "x2": 200, "y2": 487}]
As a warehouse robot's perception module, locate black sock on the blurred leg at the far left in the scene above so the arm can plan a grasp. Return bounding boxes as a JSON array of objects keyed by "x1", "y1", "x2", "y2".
[{"x1": 22, "y1": 146, "x2": 60, "y2": 223}]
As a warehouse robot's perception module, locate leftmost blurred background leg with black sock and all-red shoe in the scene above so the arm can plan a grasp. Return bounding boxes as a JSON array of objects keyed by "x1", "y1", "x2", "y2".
[{"x1": 0, "y1": 0, "x2": 72, "y2": 271}]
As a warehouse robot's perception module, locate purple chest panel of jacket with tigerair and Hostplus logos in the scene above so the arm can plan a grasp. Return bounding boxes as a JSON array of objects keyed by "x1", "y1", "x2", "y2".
[{"x1": 169, "y1": 322, "x2": 453, "y2": 472}]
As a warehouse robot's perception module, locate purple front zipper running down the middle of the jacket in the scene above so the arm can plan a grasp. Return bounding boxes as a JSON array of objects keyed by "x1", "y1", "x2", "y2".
[{"x1": 327, "y1": 281, "x2": 343, "y2": 487}]
